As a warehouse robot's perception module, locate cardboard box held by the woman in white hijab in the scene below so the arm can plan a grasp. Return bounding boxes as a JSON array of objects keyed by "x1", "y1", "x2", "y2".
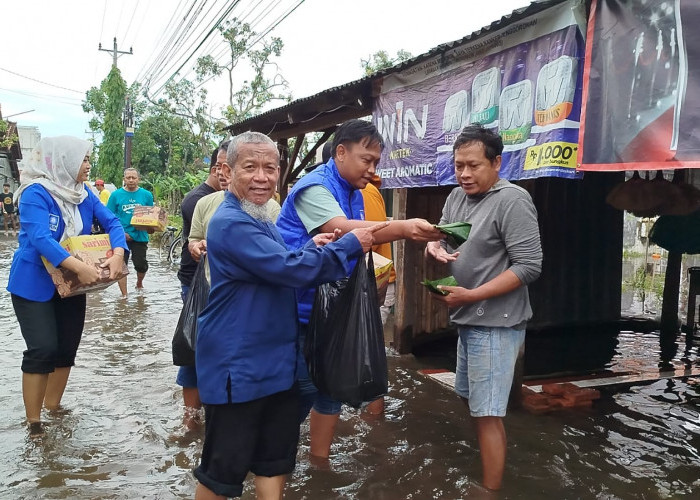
[{"x1": 42, "y1": 234, "x2": 129, "y2": 298}]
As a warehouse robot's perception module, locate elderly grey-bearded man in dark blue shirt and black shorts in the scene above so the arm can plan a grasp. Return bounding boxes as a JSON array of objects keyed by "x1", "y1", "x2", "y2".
[{"x1": 194, "y1": 132, "x2": 386, "y2": 499}]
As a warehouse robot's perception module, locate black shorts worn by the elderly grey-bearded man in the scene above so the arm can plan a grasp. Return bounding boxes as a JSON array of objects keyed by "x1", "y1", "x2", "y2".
[{"x1": 194, "y1": 384, "x2": 299, "y2": 497}]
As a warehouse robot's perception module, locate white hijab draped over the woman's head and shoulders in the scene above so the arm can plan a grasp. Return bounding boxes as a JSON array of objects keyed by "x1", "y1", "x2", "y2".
[{"x1": 15, "y1": 135, "x2": 92, "y2": 240}]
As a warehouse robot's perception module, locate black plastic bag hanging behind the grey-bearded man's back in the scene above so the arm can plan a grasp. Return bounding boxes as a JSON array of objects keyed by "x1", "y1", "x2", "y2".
[{"x1": 173, "y1": 257, "x2": 209, "y2": 366}]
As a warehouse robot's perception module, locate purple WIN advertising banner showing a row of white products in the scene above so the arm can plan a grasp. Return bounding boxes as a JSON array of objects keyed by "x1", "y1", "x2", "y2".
[{"x1": 372, "y1": 0, "x2": 585, "y2": 188}]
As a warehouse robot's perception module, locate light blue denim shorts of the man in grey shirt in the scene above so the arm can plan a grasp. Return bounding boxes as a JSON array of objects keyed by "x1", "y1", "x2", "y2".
[{"x1": 455, "y1": 326, "x2": 525, "y2": 417}]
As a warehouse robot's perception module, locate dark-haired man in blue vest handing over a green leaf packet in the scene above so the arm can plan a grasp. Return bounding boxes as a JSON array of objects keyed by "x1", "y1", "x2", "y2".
[{"x1": 277, "y1": 120, "x2": 442, "y2": 459}]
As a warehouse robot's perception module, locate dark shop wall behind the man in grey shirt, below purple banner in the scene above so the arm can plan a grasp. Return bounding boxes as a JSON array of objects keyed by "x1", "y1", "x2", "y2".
[{"x1": 393, "y1": 173, "x2": 624, "y2": 354}]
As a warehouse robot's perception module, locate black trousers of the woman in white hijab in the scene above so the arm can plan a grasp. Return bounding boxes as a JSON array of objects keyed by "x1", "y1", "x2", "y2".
[{"x1": 12, "y1": 292, "x2": 86, "y2": 373}]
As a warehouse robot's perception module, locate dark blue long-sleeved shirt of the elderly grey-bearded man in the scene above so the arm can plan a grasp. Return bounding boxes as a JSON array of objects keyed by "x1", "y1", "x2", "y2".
[{"x1": 195, "y1": 191, "x2": 362, "y2": 404}]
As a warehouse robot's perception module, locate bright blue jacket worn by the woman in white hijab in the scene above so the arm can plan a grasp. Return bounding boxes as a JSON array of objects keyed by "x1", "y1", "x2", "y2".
[{"x1": 7, "y1": 184, "x2": 127, "y2": 302}]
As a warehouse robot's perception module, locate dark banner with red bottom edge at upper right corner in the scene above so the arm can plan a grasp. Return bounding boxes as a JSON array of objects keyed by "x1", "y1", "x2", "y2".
[{"x1": 579, "y1": 0, "x2": 700, "y2": 171}]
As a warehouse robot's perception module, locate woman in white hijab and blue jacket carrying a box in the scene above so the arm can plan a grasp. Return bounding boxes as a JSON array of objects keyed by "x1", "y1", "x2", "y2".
[{"x1": 7, "y1": 136, "x2": 126, "y2": 432}]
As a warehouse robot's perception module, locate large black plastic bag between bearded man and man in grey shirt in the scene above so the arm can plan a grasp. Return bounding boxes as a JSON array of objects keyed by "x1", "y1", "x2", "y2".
[{"x1": 304, "y1": 253, "x2": 388, "y2": 408}]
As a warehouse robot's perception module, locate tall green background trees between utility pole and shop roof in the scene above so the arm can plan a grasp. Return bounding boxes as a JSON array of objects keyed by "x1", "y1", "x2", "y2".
[{"x1": 83, "y1": 20, "x2": 290, "y2": 214}]
